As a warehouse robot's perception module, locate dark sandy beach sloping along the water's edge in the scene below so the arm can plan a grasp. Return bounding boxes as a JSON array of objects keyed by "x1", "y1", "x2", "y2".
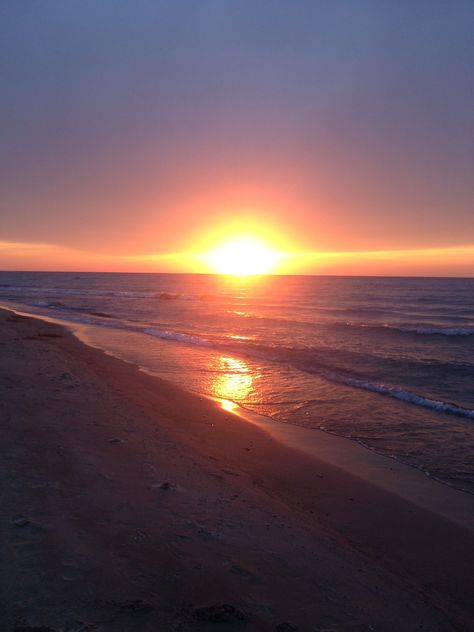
[{"x1": 0, "y1": 310, "x2": 474, "y2": 632}]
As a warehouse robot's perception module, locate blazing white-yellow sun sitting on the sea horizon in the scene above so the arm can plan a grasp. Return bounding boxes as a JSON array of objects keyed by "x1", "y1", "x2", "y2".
[{"x1": 206, "y1": 238, "x2": 281, "y2": 276}]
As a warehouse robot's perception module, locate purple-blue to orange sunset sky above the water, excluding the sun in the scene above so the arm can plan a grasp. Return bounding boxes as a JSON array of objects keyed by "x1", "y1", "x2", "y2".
[{"x1": 0, "y1": 0, "x2": 474, "y2": 276}]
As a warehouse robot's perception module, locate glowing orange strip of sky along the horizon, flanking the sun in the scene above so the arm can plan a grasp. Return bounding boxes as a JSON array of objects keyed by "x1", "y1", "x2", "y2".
[{"x1": 0, "y1": 237, "x2": 474, "y2": 277}]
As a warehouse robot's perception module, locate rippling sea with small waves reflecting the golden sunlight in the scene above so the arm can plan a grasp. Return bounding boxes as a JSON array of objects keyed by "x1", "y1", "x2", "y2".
[{"x1": 0, "y1": 272, "x2": 474, "y2": 493}]
